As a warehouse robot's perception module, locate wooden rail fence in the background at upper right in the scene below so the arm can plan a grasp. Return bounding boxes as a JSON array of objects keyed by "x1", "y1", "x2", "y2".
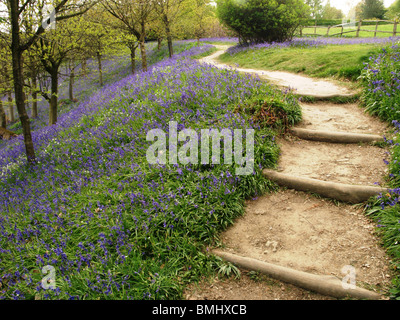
[{"x1": 298, "y1": 20, "x2": 400, "y2": 37}]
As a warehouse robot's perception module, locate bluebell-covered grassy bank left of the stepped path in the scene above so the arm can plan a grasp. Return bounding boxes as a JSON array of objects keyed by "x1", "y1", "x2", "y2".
[{"x1": 0, "y1": 40, "x2": 301, "y2": 300}]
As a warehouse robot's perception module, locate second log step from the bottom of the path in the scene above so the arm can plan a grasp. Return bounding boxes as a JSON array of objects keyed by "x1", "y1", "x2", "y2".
[{"x1": 263, "y1": 169, "x2": 388, "y2": 204}]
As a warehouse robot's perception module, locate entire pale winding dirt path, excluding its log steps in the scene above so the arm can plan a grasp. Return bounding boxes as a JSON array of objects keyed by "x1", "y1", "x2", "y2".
[{"x1": 185, "y1": 47, "x2": 391, "y2": 300}]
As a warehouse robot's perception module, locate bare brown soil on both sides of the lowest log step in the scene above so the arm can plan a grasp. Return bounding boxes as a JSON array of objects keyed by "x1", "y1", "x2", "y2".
[{"x1": 186, "y1": 190, "x2": 391, "y2": 300}]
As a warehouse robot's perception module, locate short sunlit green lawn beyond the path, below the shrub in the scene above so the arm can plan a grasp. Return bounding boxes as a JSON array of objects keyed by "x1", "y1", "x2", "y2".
[{"x1": 220, "y1": 44, "x2": 388, "y2": 81}]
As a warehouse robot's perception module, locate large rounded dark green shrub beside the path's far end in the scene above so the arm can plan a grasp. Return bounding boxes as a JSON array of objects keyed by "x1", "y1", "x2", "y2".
[{"x1": 217, "y1": 0, "x2": 308, "y2": 44}]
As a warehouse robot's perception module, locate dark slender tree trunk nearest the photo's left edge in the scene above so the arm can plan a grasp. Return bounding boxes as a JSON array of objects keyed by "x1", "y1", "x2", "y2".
[{"x1": 8, "y1": 1, "x2": 36, "y2": 164}]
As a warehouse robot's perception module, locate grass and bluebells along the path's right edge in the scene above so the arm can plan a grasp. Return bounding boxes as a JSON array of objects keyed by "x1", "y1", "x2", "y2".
[{"x1": 361, "y1": 45, "x2": 400, "y2": 300}]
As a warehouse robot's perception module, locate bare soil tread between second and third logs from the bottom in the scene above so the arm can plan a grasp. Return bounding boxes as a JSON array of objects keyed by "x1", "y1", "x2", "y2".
[{"x1": 278, "y1": 137, "x2": 387, "y2": 186}]
